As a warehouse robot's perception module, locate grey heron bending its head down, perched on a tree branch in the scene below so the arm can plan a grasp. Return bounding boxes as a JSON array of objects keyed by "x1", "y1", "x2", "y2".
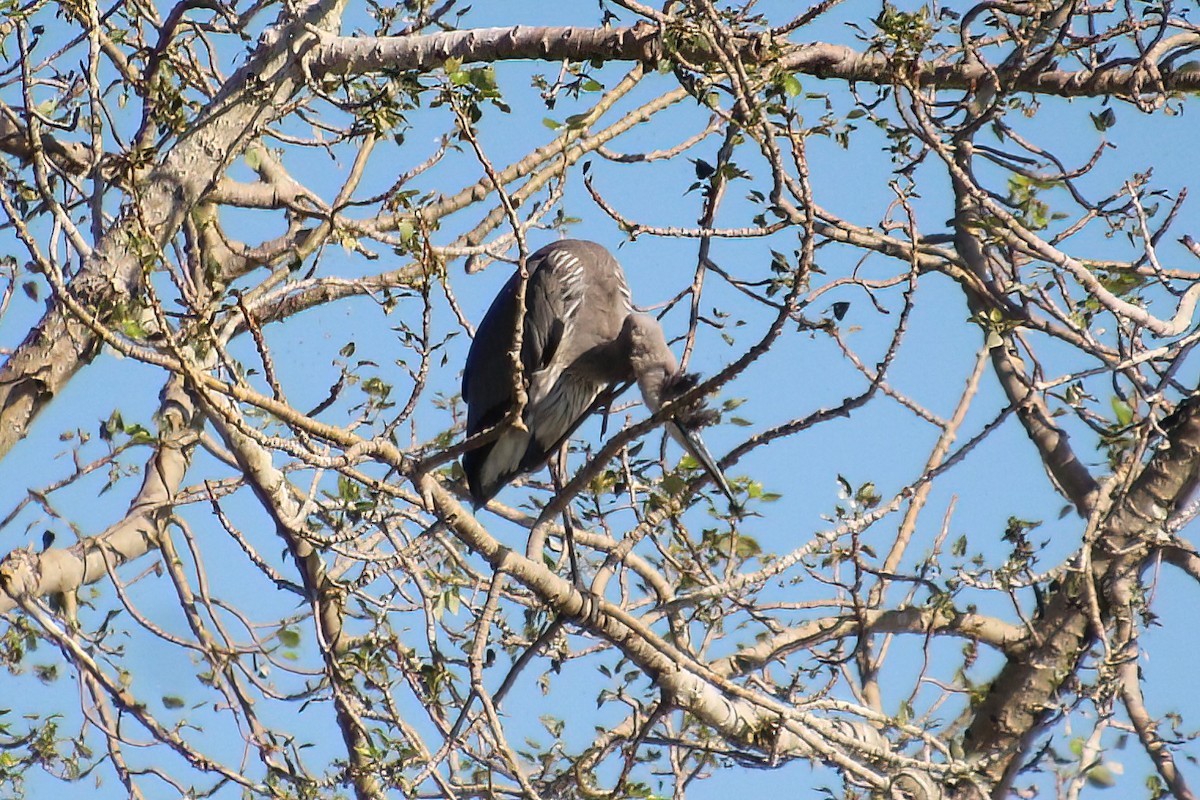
[{"x1": 462, "y1": 240, "x2": 738, "y2": 506}]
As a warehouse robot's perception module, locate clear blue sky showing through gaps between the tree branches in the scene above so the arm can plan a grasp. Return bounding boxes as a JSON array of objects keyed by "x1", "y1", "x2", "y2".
[{"x1": 0, "y1": 0, "x2": 1198, "y2": 799}]
